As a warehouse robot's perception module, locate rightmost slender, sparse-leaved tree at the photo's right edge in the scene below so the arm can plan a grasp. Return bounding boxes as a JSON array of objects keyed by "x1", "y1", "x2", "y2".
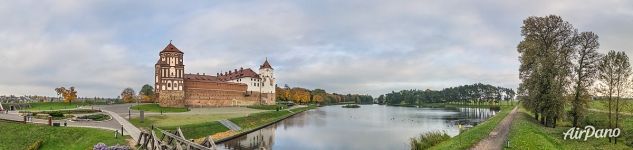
[{"x1": 598, "y1": 50, "x2": 631, "y2": 143}]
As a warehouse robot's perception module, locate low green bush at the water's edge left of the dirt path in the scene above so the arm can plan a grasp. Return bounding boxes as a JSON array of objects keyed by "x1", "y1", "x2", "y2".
[{"x1": 409, "y1": 131, "x2": 451, "y2": 150}]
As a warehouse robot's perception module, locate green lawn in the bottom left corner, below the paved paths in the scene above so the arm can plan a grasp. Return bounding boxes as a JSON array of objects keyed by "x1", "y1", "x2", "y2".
[{"x1": 0, "y1": 121, "x2": 129, "y2": 150}]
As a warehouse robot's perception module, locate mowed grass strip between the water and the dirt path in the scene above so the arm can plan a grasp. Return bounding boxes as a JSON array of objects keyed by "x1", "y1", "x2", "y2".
[{"x1": 430, "y1": 105, "x2": 514, "y2": 150}]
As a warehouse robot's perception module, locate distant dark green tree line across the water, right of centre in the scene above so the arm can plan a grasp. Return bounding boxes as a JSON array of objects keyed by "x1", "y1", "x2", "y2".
[{"x1": 377, "y1": 83, "x2": 515, "y2": 105}]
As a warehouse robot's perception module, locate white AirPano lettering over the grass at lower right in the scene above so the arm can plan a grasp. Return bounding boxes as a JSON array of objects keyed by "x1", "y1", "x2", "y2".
[{"x1": 563, "y1": 126, "x2": 620, "y2": 141}]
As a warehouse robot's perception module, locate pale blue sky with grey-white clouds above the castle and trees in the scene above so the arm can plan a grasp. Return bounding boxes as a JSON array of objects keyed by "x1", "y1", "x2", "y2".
[{"x1": 0, "y1": 0, "x2": 633, "y2": 97}]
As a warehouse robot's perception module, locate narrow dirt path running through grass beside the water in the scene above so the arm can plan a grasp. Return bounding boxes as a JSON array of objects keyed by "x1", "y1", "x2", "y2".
[{"x1": 471, "y1": 106, "x2": 519, "y2": 150}]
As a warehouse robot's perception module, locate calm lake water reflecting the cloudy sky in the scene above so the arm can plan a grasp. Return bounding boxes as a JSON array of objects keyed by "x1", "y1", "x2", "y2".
[{"x1": 218, "y1": 105, "x2": 496, "y2": 150}]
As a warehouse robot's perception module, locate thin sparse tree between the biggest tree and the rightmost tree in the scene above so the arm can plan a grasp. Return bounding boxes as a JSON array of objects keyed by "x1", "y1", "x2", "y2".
[{"x1": 571, "y1": 32, "x2": 601, "y2": 127}]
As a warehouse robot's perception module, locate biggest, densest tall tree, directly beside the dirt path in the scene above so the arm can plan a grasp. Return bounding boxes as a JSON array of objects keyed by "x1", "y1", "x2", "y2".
[{"x1": 517, "y1": 15, "x2": 577, "y2": 127}]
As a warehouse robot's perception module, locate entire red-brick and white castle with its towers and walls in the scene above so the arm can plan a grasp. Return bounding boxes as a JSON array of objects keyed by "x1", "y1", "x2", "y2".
[{"x1": 154, "y1": 42, "x2": 275, "y2": 107}]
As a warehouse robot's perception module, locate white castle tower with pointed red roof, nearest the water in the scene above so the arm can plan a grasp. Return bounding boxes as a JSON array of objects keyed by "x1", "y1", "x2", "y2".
[{"x1": 259, "y1": 58, "x2": 276, "y2": 104}]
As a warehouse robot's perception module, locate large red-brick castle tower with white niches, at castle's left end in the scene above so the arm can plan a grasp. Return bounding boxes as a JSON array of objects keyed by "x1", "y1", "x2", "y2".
[{"x1": 154, "y1": 41, "x2": 185, "y2": 107}]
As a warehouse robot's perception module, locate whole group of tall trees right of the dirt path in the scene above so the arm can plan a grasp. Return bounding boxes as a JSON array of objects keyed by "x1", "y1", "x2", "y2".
[{"x1": 517, "y1": 15, "x2": 631, "y2": 144}]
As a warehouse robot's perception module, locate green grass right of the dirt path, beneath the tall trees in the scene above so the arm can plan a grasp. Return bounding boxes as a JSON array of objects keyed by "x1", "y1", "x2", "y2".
[{"x1": 506, "y1": 109, "x2": 633, "y2": 150}]
